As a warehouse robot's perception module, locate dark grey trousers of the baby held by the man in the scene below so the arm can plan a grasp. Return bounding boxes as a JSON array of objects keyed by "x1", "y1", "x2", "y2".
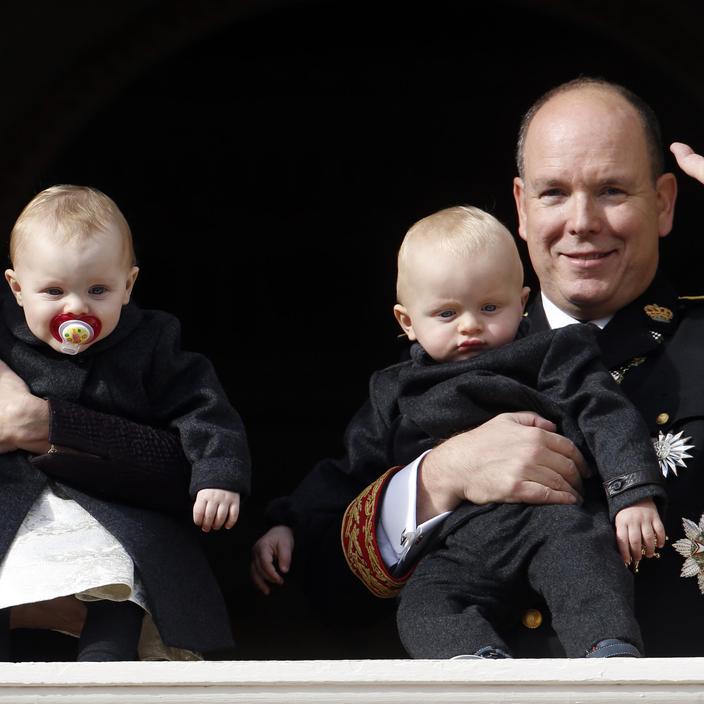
[{"x1": 397, "y1": 504, "x2": 642, "y2": 658}]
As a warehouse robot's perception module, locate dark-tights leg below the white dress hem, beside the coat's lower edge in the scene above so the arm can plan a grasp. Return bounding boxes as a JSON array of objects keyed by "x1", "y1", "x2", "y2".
[{"x1": 77, "y1": 601, "x2": 144, "y2": 662}]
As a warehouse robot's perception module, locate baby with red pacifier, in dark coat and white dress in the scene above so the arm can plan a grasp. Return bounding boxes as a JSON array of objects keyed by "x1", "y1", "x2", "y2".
[{"x1": 0, "y1": 186, "x2": 250, "y2": 660}]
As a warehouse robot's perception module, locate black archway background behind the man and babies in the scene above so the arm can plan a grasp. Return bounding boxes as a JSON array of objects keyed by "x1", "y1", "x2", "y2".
[{"x1": 0, "y1": 0, "x2": 704, "y2": 658}]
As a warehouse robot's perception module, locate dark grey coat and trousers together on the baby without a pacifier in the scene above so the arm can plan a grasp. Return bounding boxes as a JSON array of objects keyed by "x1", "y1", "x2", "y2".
[{"x1": 390, "y1": 325, "x2": 665, "y2": 658}]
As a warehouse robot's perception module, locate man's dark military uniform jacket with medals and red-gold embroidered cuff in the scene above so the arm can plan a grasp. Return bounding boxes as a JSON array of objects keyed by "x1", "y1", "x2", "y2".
[{"x1": 343, "y1": 276, "x2": 704, "y2": 656}]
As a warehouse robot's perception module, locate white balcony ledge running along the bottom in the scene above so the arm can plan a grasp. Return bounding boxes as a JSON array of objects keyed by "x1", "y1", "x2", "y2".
[{"x1": 0, "y1": 658, "x2": 704, "y2": 704}]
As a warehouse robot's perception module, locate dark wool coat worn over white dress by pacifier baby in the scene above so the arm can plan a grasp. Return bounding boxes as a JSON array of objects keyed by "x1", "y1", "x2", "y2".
[{"x1": 0, "y1": 297, "x2": 249, "y2": 651}]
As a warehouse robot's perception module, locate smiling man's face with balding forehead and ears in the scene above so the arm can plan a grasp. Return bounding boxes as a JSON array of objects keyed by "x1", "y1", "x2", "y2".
[{"x1": 514, "y1": 87, "x2": 677, "y2": 320}]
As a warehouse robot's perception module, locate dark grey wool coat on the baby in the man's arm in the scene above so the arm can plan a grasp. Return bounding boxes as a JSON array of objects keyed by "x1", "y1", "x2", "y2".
[{"x1": 270, "y1": 316, "x2": 665, "y2": 533}]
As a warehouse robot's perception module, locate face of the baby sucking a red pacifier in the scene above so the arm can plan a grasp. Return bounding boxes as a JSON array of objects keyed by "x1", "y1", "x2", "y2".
[{"x1": 5, "y1": 220, "x2": 138, "y2": 351}]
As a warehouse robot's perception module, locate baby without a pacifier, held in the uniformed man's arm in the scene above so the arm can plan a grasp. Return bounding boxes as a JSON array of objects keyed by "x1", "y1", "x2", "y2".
[{"x1": 255, "y1": 207, "x2": 665, "y2": 658}]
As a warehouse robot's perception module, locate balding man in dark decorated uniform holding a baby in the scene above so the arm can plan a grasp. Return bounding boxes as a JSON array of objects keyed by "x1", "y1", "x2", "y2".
[{"x1": 343, "y1": 79, "x2": 704, "y2": 656}]
